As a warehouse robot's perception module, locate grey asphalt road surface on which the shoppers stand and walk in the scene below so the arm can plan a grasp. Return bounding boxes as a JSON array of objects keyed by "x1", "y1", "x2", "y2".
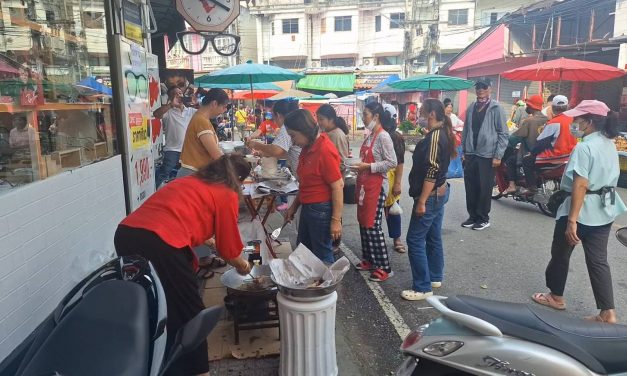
[{"x1": 337, "y1": 153, "x2": 627, "y2": 376}]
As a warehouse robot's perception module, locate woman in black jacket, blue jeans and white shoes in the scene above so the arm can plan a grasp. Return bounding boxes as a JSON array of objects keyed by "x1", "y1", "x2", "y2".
[{"x1": 401, "y1": 99, "x2": 456, "y2": 300}]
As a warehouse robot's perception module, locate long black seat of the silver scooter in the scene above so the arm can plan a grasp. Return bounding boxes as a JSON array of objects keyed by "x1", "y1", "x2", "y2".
[{"x1": 443, "y1": 295, "x2": 627, "y2": 374}]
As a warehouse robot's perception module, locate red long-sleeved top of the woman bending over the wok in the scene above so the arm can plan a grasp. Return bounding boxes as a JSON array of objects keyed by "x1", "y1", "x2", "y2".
[{"x1": 120, "y1": 176, "x2": 244, "y2": 268}]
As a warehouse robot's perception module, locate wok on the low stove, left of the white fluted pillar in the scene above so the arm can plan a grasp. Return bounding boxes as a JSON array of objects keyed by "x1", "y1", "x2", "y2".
[{"x1": 220, "y1": 265, "x2": 276, "y2": 296}]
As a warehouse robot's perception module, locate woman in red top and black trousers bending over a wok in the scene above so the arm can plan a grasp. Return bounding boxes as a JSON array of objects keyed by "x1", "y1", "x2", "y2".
[{"x1": 115, "y1": 155, "x2": 251, "y2": 375}]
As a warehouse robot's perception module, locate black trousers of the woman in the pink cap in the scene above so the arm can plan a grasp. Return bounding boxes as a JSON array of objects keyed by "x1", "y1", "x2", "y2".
[{"x1": 545, "y1": 217, "x2": 614, "y2": 310}]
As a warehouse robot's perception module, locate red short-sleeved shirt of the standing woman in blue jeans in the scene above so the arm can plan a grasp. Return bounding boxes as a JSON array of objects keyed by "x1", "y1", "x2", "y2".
[{"x1": 297, "y1": 133, "x2": 342, "y2": 204}]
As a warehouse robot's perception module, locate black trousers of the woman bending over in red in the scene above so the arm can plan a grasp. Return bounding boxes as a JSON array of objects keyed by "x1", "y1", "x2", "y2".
[{"x1": 114, "y1": 226, "x2": 209, "y2": 376}]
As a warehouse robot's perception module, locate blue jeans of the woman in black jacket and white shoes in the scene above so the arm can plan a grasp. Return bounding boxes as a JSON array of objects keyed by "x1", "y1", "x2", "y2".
[{"x1": 407, "y1": 187, "x2": 450, "y2": 292}]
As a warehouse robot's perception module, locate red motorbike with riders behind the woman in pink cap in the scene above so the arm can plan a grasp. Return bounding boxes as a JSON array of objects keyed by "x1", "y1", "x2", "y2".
[{"x1": 492, "y1": 160, "x2": 568, "y2": 218}]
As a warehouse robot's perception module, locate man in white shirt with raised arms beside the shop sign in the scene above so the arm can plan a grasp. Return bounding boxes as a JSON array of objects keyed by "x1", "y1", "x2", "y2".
[{"x1": 153, "y1": 86, "x2": 196, "y2": 189}]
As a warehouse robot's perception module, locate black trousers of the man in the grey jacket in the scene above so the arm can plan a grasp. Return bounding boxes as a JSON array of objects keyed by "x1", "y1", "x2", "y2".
[{"x1": 464, "y1": 155, "x2": 494, "y2": 222}]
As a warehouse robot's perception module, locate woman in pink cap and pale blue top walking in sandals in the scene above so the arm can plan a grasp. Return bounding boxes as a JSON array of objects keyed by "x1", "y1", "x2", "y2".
[{"x1": 532, "y1": 100, "x2": 627, "y2": 323}]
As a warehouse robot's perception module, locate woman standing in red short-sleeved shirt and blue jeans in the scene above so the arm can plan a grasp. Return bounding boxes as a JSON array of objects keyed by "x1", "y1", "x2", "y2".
[{"x1": 284, "y1": 110, "x2": 344, "y2": 263}]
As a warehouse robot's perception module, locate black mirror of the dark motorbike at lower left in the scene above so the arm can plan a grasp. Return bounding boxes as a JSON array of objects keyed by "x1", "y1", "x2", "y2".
[{"x1": 159, "y1": 307, "x2": 223, "y2": 376}]
